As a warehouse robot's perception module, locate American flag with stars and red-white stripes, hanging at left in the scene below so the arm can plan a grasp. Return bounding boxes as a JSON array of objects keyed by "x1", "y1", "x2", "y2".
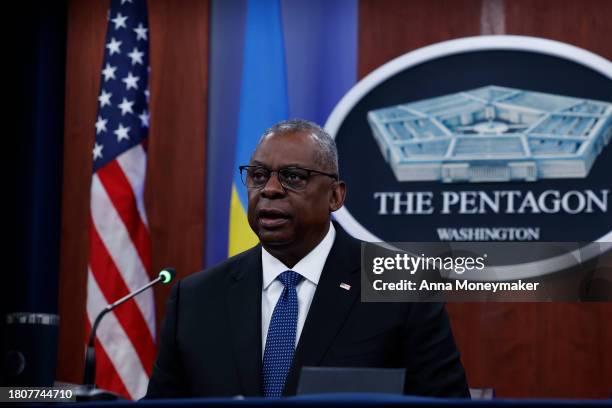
[{"x1": 87, "y1": 0, "x2": 155, "y2": 399}]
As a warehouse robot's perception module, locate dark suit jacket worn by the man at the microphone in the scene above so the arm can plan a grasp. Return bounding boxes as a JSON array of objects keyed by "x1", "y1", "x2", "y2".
[{"x1": 147, "y1": 224, "x2": 469, "y2": 398}]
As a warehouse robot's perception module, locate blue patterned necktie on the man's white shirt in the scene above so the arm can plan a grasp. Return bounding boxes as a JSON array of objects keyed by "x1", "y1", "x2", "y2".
[{"x1": 262, "y1": 271, "x2": 303, "y2": 397}]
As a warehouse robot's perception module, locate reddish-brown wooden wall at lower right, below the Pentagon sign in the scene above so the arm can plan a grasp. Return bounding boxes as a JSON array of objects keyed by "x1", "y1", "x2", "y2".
[{"x1": 447, "y1": 302, "x2": 612, "y2": 398}]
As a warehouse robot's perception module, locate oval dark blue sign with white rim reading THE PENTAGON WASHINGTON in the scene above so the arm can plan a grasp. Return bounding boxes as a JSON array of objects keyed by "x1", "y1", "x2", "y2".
[{"x1": 325, "y1": 36, "x2": 612, "y2": 278}]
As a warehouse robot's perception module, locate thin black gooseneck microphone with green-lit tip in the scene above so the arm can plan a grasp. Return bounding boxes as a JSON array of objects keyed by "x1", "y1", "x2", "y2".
[{"x1": 75, "y1": 268, "x2": 176, "y2": 401}]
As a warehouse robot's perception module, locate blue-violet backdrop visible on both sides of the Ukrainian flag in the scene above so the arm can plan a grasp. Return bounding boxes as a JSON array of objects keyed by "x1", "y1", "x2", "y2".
[{"x1": 204, "y1": 0, "x2": 357, "y2": 267}]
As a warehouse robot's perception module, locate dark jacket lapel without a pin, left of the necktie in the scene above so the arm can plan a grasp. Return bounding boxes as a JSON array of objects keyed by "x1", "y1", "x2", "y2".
[{"x1": 227, "y1": 245, "x2": 263, "y2": 396}]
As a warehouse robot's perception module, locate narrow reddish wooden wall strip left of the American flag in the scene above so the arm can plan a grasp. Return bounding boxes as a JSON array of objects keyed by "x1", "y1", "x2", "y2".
[{"x1": 57, "y1": 0, "x2": 109, "y2": 383}]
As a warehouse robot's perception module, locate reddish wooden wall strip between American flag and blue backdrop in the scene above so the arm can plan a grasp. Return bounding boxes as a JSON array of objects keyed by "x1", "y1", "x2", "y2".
[{"x1": 145, "y1": 0, "x2": 209, "y2": 338}]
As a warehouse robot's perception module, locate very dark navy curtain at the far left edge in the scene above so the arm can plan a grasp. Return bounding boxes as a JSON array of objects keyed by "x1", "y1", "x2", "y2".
[{"x1": 11, "y1": 1, "x2": 67, "y2": 321}]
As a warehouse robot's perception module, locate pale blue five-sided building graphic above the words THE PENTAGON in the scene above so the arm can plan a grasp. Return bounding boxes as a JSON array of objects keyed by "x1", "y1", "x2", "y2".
[{"x1": 368, "y1": 86, "x2": 612, "y2": 183}]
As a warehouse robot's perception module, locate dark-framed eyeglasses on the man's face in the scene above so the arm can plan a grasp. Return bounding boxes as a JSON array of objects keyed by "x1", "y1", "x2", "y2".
[{"x1": 239, "y1": 166, "x2": 338, "y2": 190}]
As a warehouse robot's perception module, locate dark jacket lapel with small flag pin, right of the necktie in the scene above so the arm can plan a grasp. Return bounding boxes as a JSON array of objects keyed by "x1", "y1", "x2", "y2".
[{"x1": 283, "y1": 223, "x2": 361, "y2": 395}]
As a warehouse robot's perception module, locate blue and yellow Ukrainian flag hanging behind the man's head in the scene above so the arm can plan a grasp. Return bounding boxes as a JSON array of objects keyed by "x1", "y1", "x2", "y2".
[{"x1": 228, "y1": 0, "x2": 288, "y2": 256}]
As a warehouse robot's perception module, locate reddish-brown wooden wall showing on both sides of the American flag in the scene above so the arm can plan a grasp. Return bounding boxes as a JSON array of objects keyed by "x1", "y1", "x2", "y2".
[{"x1": 57, "y1": 0, "x2": 209, "y2": 382}]
